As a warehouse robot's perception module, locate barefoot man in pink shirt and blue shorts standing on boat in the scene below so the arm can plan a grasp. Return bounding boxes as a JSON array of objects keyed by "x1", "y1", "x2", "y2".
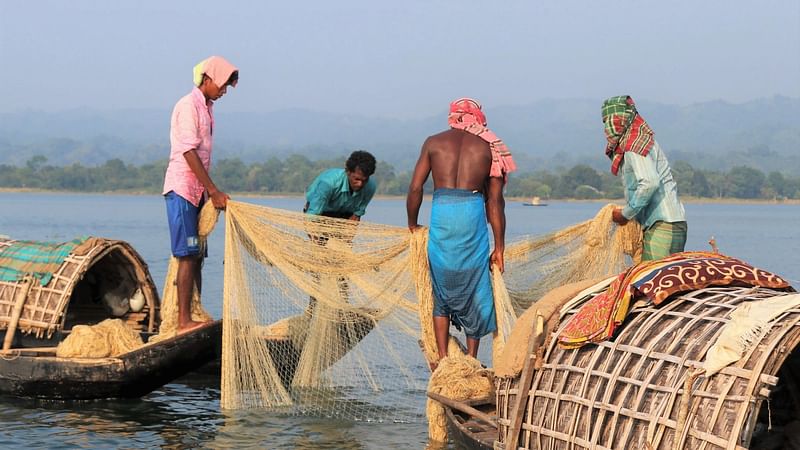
[{"x1": 162, "y1": 56, "x2": 239, "y2": 333}]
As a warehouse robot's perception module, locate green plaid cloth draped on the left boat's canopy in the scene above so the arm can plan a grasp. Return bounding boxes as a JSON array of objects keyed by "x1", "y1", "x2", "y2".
[{"x1": 0, "y1": 237, "x2": 87, "y2": 286}]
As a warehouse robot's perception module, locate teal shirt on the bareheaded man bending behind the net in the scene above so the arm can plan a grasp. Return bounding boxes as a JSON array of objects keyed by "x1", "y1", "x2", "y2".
[{"x1": 306, "y1": 169, "x2": 378, "y2": 217}]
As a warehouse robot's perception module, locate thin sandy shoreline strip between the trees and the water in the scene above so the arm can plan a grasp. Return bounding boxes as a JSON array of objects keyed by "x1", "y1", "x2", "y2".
[{"x1": 0, "y1": 188, "x2": 800, "y2": 205}]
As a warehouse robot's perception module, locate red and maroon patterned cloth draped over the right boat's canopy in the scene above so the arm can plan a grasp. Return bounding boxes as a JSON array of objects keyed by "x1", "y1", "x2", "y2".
[{"x1": 558, "y1": 252, "x2": 791, "y2": 348}]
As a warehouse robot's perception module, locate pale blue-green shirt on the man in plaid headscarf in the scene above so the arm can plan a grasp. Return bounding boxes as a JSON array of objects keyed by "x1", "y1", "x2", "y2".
[{"x1": 621, "y1": 142, "x2": 686, "y2": 229}]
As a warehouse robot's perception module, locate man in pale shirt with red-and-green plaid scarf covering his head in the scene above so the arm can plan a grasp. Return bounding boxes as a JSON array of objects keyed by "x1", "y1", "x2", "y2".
[{"x1": 602, "y1": 95, "x2": 687, "y2": 261}]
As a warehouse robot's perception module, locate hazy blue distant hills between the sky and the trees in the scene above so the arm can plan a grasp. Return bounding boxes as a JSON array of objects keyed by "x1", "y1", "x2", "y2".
[{"x1": 0, "y1": 97, "x2": 800, "y2": 173}]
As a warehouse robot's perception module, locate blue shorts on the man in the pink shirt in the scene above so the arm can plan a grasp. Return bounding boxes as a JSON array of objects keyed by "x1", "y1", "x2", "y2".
[{"x1": 164, "y1": 191, "x2": 208, "y2": 258}]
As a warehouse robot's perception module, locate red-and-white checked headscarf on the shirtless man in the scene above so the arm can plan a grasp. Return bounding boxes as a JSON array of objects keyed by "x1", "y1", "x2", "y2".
[{"x1": 447, "y1": 98, "x2": 517, "y2": 182}]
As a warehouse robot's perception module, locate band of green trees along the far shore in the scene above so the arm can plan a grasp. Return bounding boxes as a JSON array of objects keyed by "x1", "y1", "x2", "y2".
[{"x1": 0, "y1": 155, "x2": 800, "y2": 199}]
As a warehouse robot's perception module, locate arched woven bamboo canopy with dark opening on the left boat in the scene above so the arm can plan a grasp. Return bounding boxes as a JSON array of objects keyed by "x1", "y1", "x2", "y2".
[{"x1": 0, "y1": 237, "x2": 159, "y2": 340}]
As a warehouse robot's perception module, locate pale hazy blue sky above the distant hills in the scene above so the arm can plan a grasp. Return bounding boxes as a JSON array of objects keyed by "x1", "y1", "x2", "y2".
[{"x1": 0, "y1": 0, "x2": 800, "y2": 118}]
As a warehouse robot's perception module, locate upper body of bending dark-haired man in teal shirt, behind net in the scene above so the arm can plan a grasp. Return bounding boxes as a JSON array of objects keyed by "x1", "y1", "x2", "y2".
[{"x1": 303, "y1": 150, "x2": 378, "y2": 221}]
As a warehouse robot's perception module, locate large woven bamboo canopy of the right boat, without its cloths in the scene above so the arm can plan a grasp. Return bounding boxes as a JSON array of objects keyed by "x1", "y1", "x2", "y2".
[{"x1": 495, "y1": 287, "x2": 800, "y2": 449}]
